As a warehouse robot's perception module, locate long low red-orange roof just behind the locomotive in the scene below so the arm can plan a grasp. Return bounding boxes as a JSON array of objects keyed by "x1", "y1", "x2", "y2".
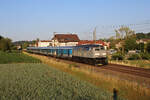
[{"x1": 78, "y1": 40, "x2": 105, "y2": 45}]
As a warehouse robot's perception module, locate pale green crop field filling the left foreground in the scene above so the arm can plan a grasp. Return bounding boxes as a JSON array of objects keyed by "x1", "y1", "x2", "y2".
[{"x1": 0, "y1": 63, "x2": 118, "y2": 100}]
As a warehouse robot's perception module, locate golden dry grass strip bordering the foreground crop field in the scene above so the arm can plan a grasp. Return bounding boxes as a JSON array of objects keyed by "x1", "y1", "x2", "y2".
[{"x1": 24, "y1": 54, "x2": 150, "y2": 100}]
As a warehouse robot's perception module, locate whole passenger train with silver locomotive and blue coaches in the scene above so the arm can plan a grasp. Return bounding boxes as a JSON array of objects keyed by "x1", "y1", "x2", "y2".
[{"x1": 27, "y1": 44, "x2": 108, "y2": 65}]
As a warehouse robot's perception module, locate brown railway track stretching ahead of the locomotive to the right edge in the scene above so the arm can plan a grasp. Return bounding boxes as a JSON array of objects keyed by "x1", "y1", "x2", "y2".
[{"x1": 101, "y1": 64, "x2": 150, "y2": 78}]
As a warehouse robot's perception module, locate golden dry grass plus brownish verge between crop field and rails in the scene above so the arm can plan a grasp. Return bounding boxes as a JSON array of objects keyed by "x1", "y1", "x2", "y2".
[{"x1": 27, "y1": 53, "x2": 150, "y2": 100}]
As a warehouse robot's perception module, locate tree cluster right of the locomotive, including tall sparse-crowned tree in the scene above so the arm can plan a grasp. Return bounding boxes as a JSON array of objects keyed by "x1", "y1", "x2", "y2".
[{"x1": 107, "y1": 27, "x2": 150, "y2": 53}]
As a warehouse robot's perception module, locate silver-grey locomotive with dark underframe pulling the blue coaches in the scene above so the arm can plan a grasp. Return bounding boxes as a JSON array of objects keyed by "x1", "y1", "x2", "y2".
[{"x1": 73, "y1": 45, "x2": 108, "y2": 65}]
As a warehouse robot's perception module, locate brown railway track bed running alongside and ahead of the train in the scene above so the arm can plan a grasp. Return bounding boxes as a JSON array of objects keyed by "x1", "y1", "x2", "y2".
[{"x1": 27, "y1": 51, "x2": 150, "y2": 78}]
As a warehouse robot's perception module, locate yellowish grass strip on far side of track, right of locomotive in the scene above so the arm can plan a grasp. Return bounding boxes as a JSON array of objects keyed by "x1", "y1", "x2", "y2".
[{"x1": 109, "y1": 60, "x2": 150, "y2": 69}]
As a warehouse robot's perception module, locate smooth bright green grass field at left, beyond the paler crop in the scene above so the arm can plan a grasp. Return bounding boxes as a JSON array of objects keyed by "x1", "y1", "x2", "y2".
[{"x1": 0, "y1": 51, "x2": 41, "y2": 64}]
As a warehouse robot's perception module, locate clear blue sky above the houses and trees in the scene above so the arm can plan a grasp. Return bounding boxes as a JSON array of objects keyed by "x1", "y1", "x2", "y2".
[{"x1": 0, "y1": 0, "x2": 150, "y2": 41}]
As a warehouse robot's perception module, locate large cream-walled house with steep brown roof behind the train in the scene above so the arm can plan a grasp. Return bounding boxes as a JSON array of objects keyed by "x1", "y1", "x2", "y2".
[{"x1": 52, "y1": 34, "x2": 80, "y2": 46}]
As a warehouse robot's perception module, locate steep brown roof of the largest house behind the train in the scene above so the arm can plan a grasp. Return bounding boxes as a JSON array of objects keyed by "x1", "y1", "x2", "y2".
[{"x1": 52, "y1": 34, "x2": 80, "y2": 42}]
